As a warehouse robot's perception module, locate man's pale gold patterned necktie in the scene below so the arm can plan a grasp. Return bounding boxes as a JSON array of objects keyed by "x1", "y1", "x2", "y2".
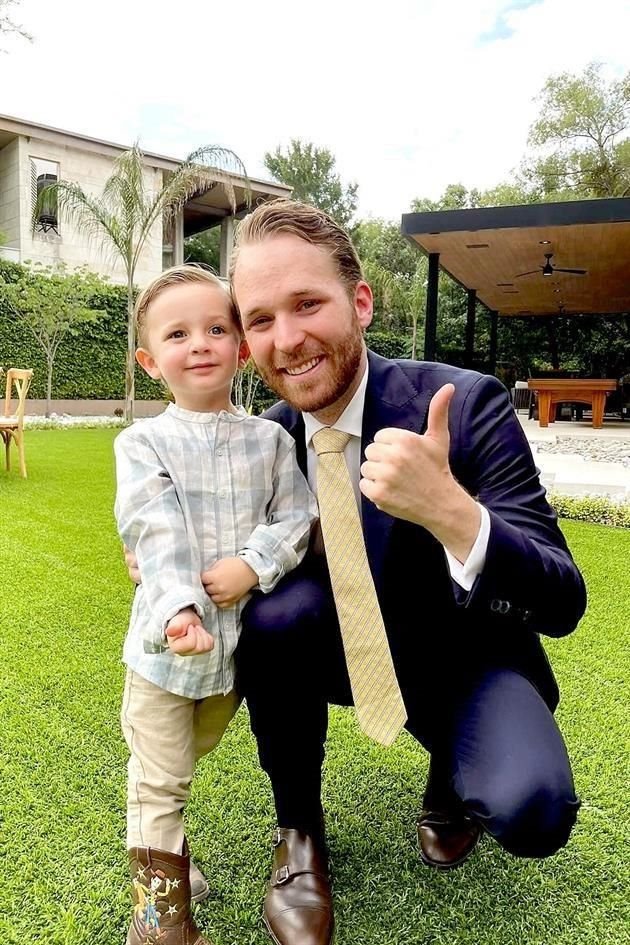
[{"x1": 313, "y1": 427, "x2": 407, "y2": 745}]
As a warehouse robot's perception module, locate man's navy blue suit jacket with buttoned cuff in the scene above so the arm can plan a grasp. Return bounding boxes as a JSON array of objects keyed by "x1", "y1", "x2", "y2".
[{"x1": 266, "y1": 352, "x2": 586, "y2": 709}]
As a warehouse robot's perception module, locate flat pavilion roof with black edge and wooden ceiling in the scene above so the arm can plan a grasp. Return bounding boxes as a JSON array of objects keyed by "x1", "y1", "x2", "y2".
[{"x1": 402, "y1": 198, "x2": 630, "y2": 315}]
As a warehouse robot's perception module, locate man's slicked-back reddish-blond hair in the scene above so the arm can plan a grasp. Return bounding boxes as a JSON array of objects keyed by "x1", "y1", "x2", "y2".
[{"x1": 230, "y1": 197, "x2": 363, "y2": 295}]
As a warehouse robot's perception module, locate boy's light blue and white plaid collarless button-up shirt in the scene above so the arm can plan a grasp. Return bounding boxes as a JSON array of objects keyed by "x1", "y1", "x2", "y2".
[{"x1": 114, "y1": 404, "x2": 317, "y2": 699}]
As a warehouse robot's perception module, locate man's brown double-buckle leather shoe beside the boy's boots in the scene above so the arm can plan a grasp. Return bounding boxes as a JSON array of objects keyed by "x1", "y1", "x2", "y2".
[{"x1": 263, "y1": 827, "x2": 334, "y2": 945}]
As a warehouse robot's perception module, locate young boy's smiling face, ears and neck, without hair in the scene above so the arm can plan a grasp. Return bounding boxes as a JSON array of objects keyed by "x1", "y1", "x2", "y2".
[{"x1": 136, "y1": 282, "x2": 248, "y2": 411}]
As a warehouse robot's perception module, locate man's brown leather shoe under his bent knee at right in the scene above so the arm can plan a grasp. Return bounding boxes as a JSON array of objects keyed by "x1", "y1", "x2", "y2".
[{"x1": 418, "y1": 810, "x2": 481, "y2": 870}]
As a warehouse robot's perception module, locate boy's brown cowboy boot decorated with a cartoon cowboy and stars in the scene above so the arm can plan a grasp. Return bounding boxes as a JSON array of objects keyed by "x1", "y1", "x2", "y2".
[{"x1": 127, "y1": 843, "x2": 211, "y2": 945}]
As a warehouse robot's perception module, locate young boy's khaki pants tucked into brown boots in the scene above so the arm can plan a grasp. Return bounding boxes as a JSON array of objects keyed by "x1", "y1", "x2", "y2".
[{"x1": 121, "y1": 670, "x2": 240, "y2": 854}]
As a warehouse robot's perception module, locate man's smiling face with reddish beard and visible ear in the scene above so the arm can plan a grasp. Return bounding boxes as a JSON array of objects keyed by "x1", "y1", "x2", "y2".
[{"x1": 233, "y1": 234, "x2": 372, "y2": 423}]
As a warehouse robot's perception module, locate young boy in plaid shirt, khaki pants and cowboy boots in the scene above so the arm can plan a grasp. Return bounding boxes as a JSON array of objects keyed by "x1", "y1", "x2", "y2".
[{"x1": 115, "y1": 266, "x2": 316, "y2": 945}]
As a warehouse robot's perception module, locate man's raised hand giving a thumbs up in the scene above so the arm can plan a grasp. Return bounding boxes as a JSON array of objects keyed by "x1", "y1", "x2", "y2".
[{"x1": 359, "y1": 384, "x2": 481, "y2": 561}]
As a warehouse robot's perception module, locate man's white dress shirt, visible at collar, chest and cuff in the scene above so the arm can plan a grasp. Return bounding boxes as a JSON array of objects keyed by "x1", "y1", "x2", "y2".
[{"x1": 303, "y1": 365, "x2": 490, "y2": 591}]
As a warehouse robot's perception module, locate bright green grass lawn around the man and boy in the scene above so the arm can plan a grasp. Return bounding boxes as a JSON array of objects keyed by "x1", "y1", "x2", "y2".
[{"x1": 0, "y1": 430, "x2": 630, "y2": 945}]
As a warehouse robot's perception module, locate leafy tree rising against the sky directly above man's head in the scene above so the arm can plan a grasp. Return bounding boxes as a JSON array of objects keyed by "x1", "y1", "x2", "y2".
[{"x1": 264, "y1": 138, "x2": 358, "y2": 227}]
